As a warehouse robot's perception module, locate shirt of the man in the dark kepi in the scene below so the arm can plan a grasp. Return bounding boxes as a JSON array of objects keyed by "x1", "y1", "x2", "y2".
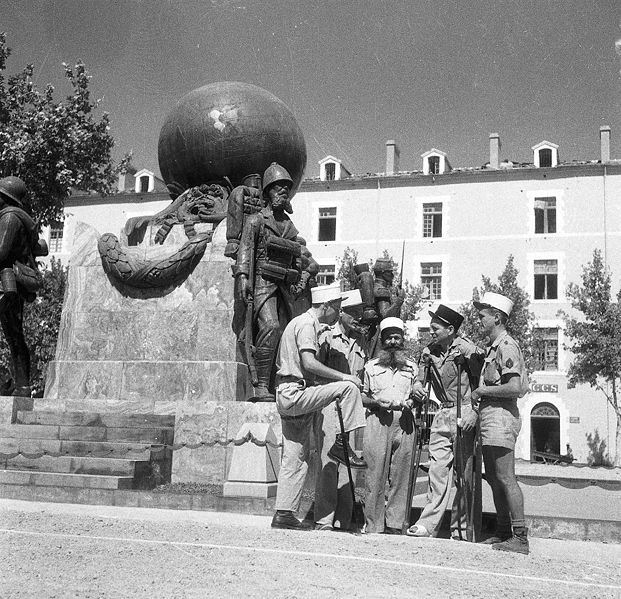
[{"x1": 418, "y1": 337, "x2": 480, "y2": 403}]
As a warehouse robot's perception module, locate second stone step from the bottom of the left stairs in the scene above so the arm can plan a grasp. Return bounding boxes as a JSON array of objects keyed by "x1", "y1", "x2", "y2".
[{"x1": 0, "y1": 455, "x2": 143, "y2": 477}]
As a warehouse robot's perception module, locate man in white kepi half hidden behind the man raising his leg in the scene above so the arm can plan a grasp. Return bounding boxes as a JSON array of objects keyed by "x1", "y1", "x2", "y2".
[{"x1": 315, "y1": 289, "x2": 367, "y2": 530}]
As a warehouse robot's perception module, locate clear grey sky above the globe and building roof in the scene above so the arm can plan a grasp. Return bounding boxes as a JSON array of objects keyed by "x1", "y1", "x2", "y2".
[{"x1": 0, "y1": 0, "x2": 621, "y2": 176}]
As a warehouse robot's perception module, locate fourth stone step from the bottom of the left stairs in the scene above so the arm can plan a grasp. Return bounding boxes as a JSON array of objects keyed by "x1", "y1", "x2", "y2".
[{"x1": 0, "y1": 424, "x2": 174, "y2": 445}]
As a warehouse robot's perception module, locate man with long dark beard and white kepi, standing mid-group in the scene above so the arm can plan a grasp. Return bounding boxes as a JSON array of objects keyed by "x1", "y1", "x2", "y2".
[{"x1": 362, "y1": 317, "x2": 416, "y2": 534}]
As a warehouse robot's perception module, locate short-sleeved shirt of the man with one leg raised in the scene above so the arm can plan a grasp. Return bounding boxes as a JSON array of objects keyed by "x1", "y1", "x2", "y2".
[{"x1": 276, "y1": 308, "x2": 323, "y2": 383}]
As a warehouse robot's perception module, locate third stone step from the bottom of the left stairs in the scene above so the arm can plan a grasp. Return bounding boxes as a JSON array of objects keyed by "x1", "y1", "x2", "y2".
[{"x1": 0, "y1": 438, "x2": 157, "y2": 461}]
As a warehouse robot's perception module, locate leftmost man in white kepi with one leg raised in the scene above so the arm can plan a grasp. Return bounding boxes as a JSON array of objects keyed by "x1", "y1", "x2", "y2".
[{"x1": 272, "y1": 285, "x2": 366, "y2": 530}]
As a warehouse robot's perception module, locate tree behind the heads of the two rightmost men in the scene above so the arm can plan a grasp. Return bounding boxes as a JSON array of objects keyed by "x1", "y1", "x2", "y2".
[{"x1": 460, "y1": 255, "x2": 535, "y2": 372}]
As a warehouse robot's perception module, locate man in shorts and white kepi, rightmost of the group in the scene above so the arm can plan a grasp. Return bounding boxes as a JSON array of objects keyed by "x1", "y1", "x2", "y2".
[{"x1": 464, "y1": 292, "x2": 529, "y2": 554}]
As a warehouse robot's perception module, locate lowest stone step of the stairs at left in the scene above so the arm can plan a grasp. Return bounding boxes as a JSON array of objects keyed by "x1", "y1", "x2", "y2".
[{"x1": 0, "y1": 470, "x2": 133, "y2": 489}]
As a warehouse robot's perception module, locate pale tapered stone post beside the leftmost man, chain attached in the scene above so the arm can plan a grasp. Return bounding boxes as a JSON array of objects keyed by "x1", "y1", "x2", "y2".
[{"x1": 224, "y1": 422, "x2": 280, "y2": 499}]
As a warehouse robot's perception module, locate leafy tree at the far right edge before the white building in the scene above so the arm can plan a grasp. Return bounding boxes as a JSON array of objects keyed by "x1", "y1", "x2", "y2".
[{"x1": 560, "y1": 250, "x2": 621, "y2": 466}]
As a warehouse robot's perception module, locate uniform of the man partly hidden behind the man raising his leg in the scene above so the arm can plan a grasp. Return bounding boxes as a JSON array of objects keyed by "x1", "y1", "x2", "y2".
[{"x1": 315, "y1": 322, "x2": 366, "y2": 530}]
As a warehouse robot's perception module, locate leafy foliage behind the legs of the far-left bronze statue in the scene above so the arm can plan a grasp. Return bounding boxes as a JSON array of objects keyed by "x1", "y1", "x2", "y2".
[{"x1": 0, "y1": 258, "x2": 67, "y2": 395}]
